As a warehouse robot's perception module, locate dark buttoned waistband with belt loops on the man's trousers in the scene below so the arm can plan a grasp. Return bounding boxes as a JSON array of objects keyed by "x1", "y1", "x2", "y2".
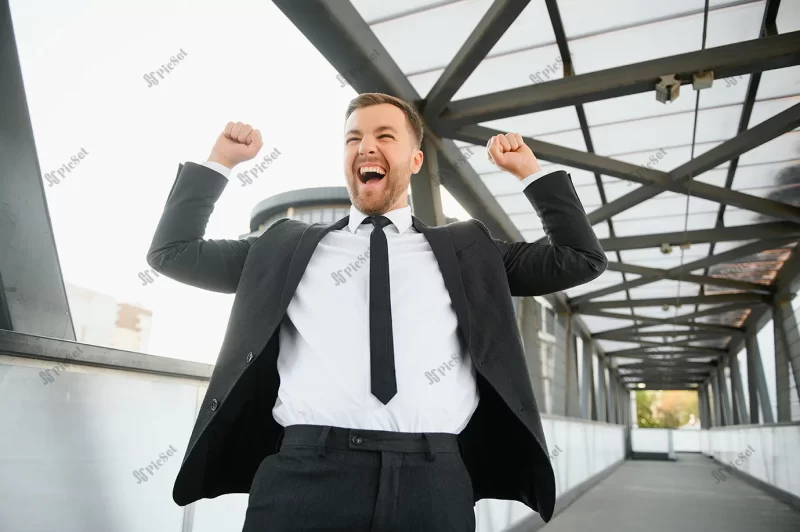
[{"x1": 279, "y1": 425, "x2": 459, "y2": 461}]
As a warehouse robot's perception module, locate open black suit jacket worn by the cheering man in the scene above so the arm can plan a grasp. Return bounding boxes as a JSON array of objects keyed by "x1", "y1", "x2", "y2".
[{"x1": 147, "y1": 163, "x2": 606, "y2": 521}]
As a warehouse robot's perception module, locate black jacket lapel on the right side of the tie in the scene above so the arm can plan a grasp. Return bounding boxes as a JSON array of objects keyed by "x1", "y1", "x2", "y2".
[{"x1": 411, "y1": 216, "x2": 471, "y2": 349}]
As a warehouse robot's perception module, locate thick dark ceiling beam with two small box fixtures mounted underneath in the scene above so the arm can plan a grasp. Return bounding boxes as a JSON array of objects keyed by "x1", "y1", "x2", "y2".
[{"x1": 438, "y1": 31, "x2": 800, "y2": 129}]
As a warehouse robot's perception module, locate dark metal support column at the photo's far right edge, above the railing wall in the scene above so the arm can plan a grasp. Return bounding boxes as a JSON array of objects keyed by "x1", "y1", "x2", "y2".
[{"x1": 772, "y1": 299, "x2": 800, "y2": 423}]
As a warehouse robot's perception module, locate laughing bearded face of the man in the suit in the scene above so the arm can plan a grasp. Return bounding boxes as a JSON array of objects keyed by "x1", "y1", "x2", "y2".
[{"x1": 344, "y1": 104, "x2": 422, "y2": 216}]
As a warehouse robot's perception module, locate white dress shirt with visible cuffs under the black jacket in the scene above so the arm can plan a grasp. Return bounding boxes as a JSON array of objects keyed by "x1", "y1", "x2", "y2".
[{"x1": 202, "y1": 161, "x2": 553, "y2": 434}]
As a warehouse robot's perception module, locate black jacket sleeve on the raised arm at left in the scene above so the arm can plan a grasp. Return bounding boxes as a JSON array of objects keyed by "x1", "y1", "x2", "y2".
[{"x1": 147, "y1": 162, "x2": 286, "y2": 294}]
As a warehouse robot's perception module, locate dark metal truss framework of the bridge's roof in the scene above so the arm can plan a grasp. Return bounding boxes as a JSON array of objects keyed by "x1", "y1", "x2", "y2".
[{"x1": 273, "y1": 0, "x2": 800, "y2": 389}]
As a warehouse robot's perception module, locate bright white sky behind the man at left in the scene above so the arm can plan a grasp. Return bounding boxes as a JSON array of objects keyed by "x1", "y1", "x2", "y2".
[{"x1": 10, "y1": 0, "x2": 468, "y2": 363}]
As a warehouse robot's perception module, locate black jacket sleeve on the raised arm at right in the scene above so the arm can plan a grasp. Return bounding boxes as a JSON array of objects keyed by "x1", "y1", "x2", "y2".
[{"x1": 475, "y1": 170, "x2": 608, "y2": 297}]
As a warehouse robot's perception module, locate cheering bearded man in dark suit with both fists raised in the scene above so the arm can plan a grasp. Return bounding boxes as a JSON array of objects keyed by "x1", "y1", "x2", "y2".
[{"x1": 147, "y1": 93, "x2": 606, "y2": 532}]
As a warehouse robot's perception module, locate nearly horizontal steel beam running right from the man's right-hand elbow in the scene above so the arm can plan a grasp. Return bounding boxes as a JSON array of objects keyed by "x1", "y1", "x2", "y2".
[{"x1": 600, "y1": 222, "x2": 800, "y2": 252}]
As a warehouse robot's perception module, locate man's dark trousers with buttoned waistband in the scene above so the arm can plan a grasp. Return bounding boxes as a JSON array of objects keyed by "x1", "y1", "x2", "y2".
[{"x1": 242, "y1": 425, "x2": 475, "y2": 532}]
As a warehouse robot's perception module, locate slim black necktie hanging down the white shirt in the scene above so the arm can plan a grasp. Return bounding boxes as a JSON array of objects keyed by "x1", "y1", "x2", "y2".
[{"x1": 364, "y1": 216, "x2": 397, "y2": 404}]
